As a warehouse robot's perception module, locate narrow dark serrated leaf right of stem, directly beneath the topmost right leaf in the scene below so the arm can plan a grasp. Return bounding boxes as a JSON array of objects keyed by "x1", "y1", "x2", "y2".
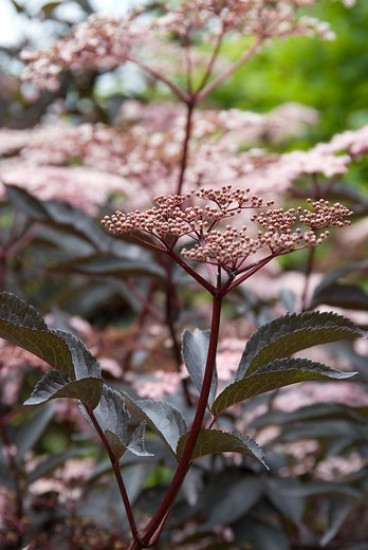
[{"x1": 212, "y1": 358, "x2": 355, "y2": 416}]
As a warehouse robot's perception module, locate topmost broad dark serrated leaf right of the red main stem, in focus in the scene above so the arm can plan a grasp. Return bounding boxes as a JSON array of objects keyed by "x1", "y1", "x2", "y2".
[{"x1": 236, "y1": 312, "x2": 363, "y2": 380}]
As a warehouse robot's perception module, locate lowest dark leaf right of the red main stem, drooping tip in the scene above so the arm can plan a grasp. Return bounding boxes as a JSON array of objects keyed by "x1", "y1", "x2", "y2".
[{"x1": 176, "y1": 429, "x2": 268, "y2": 469}]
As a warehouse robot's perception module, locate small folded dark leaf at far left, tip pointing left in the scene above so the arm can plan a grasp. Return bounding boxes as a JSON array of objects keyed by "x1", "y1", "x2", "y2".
[{"x1": 24, "y1": 370, "x2": 103, "y2": 409}]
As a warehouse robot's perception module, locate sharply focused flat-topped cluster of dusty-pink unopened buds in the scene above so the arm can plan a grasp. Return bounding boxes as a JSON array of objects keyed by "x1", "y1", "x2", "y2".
[{"x1": 102, "y1": 185, "x2": 352, "y2": 294}]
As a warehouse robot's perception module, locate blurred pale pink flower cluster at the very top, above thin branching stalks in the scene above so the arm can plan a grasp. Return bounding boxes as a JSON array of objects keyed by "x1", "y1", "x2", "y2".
[{"x1": 23, "y1": 0, "x2": 348, "y2": 90}]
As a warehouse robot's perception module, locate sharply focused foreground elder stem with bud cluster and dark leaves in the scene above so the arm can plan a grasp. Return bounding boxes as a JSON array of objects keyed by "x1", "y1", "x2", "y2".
[{"x1": 0, "y1": 186, "x2": 361, "y2": 550}]
